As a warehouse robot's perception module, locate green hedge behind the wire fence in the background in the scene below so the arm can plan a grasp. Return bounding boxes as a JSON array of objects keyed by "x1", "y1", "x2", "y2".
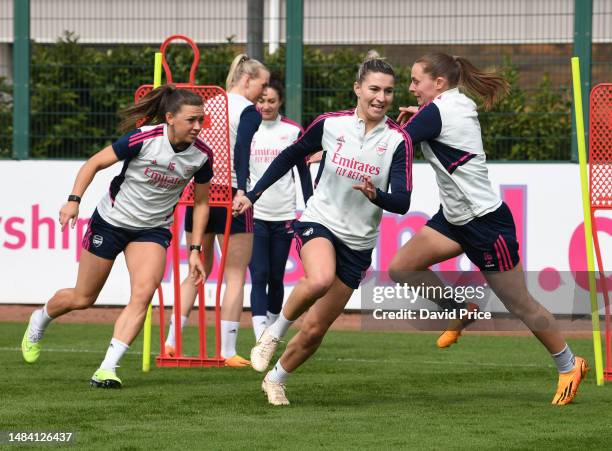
[{"x1": 0, "y1": 33, "x2": 571, "y2": 160}]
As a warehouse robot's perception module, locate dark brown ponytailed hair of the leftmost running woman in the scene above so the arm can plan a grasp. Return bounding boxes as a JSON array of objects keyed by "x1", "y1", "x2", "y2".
[{"x1": 118, "y1": 85, "x2": 203, "y2": 133}]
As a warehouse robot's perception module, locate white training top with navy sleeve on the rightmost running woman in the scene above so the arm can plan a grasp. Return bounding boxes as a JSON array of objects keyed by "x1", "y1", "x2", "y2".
[{"x1": 405, "y1": 88, "x2": 502, "y2": 225}]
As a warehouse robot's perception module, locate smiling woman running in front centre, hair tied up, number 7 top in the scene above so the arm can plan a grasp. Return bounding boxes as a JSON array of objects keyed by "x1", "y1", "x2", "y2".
[{"x1": 234, "y1": 55, "x2": 412, "y2": 405}]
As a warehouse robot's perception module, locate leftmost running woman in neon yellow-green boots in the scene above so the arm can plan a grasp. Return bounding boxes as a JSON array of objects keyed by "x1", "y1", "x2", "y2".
[{"x1": 21, "y1": 85, "x2": 212, "y2": 388}]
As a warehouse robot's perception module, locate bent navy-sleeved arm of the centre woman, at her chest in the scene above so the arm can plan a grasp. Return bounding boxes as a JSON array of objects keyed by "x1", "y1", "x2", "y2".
[{"x1": 353, "y1": 142, "x2": 412, "y2": 215}]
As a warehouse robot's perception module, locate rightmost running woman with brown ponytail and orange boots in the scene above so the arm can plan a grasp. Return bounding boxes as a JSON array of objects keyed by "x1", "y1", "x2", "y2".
[{"x1": 389, "y1": 53, "x2": 587, "y2": 405}]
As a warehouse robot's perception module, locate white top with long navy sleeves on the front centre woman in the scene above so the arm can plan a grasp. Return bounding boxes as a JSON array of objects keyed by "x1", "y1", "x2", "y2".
[{"x1": 247, "y1": 110, "x2": 412, "y2": 250}]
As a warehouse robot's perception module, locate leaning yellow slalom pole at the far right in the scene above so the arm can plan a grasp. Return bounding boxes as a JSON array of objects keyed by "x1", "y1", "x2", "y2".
[{"x1": 572, "y1": 56, "x2": 604, "y2": 385}]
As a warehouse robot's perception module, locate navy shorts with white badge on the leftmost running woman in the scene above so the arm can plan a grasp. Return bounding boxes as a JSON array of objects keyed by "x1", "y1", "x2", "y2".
[{"x1": 82, "y1": 210, "x2": 172, "y2": 260}]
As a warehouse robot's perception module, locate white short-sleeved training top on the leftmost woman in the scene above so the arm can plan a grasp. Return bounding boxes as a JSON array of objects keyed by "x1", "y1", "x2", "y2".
[{"x1": 97, "y1": 124, "x2": 213, "y2": 229}]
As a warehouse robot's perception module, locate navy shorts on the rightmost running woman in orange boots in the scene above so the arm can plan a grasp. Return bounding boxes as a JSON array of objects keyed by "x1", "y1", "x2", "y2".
[{"x1": 426, "y1": 202, "x2": 520, "y2": 271}]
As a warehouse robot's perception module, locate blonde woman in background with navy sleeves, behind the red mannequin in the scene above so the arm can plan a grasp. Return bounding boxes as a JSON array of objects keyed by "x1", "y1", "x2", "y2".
[{"x1": 166, "y1": 54, "x2": 270, "y2": 367}]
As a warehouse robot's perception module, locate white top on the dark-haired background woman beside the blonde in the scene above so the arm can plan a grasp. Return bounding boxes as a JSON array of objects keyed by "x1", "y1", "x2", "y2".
[{"x1": 249, "y1": 114, "x2": 303, "y2": 221}]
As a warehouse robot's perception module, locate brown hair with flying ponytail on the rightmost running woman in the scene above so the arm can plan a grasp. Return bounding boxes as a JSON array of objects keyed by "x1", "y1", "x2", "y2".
[{"x1": 416, "y1": 53, "x2": 510, "y2": 110}]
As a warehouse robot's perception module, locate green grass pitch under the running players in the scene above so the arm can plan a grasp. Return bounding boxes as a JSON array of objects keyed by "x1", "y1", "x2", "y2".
[{"x1": 0, "y1": 323, "x2": 612, "y2": 450}]
